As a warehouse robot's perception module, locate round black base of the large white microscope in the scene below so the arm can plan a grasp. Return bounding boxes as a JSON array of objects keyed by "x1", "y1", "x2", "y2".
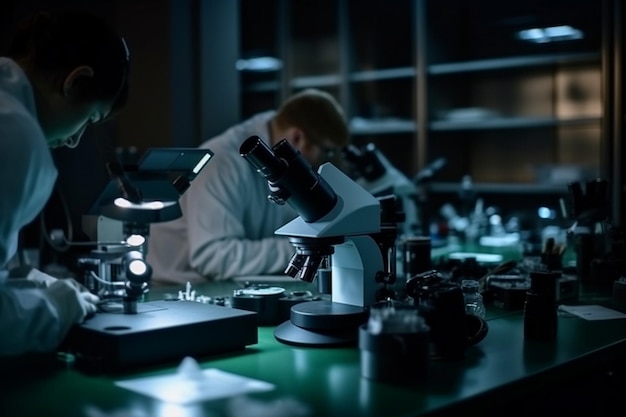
[{"x1": 274, "y1": 300, "x2": 368, "y2": 347}]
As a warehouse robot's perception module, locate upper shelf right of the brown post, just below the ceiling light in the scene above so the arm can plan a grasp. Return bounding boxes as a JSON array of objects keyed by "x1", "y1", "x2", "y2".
[{"x1": 428, "y1": 52, "x2": 600, "y2": 75}]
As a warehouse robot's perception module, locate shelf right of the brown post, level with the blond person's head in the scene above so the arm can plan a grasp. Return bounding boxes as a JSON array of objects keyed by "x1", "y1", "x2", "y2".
[{"x1": 430, "y1": 117, "x2": 601, "y2": 131}]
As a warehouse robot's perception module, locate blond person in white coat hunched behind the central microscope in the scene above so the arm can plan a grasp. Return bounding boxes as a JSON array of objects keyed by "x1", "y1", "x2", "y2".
[{"x1": 147, "y1": 89, "x2": 349, "y2": 284}]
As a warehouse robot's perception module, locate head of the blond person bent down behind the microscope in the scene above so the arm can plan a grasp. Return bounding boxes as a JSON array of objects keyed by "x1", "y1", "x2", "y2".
[{"x1": 272, "y1": 89, "x2": 350, "y2": 167}]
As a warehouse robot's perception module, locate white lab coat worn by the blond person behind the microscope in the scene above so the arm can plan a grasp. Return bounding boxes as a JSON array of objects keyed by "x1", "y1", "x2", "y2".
[{"x1": 147, "y1": 111, "x2": 296, "y2": 284}]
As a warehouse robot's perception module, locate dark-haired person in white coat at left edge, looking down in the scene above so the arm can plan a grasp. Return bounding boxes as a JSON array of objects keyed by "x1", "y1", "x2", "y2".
[{"x1": 0, "y1": 12, "x2": 129, "y2": 356}]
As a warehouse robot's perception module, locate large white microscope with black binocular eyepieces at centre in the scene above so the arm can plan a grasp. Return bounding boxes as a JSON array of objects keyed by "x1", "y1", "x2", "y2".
[{"x1": 240, "y1": 136, "x2": 396, "y2": 346}]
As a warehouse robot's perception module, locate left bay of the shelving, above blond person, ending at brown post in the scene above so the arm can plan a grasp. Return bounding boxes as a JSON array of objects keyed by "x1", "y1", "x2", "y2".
[{"x1": 240, "y1": 0, "x2": 419, "y2": 175}]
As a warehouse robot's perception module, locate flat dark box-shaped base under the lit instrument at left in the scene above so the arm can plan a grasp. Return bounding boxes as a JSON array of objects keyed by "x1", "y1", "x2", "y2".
[{"x1": 62, "y1": 300, "x2": 258, "y2": 372}]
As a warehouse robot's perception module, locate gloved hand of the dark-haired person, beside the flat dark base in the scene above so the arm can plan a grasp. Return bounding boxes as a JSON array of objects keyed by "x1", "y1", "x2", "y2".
[{"x1": 44, "y1": 278, "x2": 100, "y2": 330}]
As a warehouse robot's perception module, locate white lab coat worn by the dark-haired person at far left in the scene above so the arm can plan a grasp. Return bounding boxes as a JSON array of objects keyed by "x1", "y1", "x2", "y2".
[{"x1": 0, "y1": 57, "x2": 68, "y2": 355}]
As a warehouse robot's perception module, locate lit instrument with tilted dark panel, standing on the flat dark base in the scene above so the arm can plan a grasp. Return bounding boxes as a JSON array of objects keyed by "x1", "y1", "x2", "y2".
[{"x1": 78, "y1": 148, "x2": 213, "y2": 314}]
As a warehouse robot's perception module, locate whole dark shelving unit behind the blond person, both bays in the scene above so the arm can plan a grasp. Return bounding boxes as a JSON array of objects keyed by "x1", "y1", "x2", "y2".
[{"x1": 240, "y1": 0, "x2": 608, "y2": 206}]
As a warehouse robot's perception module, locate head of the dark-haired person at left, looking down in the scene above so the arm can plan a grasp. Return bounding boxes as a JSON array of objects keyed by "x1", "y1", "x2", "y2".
[{"x1": 7, "y1": 12, "x2": 130, "y2": 148}]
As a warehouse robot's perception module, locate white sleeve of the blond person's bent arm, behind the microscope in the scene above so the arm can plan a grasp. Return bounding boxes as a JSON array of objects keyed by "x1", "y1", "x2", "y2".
[{"x1": 184, "y1": 150, "x2": 295, "y2": 280}]
